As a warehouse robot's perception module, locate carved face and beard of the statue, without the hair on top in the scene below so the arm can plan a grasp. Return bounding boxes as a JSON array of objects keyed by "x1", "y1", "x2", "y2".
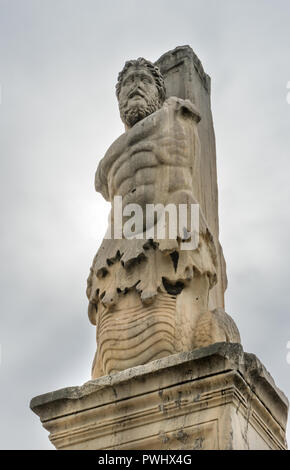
[{"x1": 119, "y1": 66, "x2": 161, "y2": 127}]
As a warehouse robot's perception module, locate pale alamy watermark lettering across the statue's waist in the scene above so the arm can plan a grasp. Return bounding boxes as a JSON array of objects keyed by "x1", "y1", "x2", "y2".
[{"x1": 105, "y1": 196, "x2": 199, "y2": 250}]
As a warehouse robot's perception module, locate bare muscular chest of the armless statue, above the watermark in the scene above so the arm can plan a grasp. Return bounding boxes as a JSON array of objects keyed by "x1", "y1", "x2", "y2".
[{"x1": 96, "y1": 97, "x2": 199, "y2": 211}]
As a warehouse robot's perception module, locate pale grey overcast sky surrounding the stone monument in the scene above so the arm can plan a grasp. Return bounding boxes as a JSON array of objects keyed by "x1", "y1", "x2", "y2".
[{"x1": 0, "y1": 0, "x2": 290, "y2": 449}]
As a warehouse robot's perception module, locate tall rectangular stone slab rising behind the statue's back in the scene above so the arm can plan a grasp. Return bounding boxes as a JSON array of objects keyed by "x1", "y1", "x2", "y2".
[{"x1": 156, "y1": 46, "x2": 227, "y2": 309}]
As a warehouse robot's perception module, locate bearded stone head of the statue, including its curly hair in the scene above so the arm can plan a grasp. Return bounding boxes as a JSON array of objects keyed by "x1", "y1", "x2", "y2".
[{"x1": 116, "y1": 57, "x2": 165, "y2": 128}]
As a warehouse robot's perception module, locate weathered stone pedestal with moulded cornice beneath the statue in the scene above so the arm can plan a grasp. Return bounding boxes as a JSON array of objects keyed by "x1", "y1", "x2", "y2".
[{"x1": 31, "y1": 343, "x2": 288, "y2": 450}]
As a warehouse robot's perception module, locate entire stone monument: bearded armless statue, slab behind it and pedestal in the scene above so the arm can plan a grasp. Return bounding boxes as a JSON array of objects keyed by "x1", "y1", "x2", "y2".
[{"x1": 30, "y1": 46, "x2": 289, "y2": 452}]
